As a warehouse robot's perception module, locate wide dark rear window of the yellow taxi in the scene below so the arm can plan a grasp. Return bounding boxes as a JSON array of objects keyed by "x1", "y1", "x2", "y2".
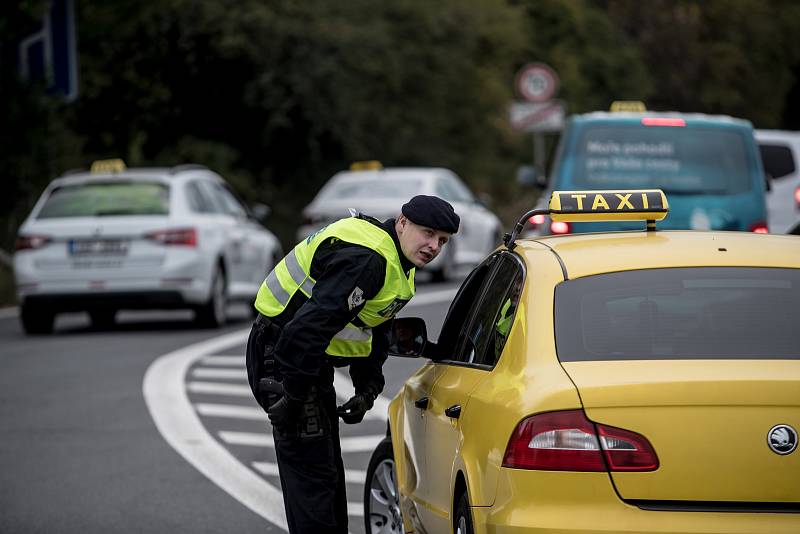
[{"x1": 555, "y1": 267, "x2": 800, "y2": 362}]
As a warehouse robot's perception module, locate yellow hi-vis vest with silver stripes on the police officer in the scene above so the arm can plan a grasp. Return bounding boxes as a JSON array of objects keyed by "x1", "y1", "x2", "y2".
[{"x1": 255, "y1": 217, "x2": 415, "y2": 357}]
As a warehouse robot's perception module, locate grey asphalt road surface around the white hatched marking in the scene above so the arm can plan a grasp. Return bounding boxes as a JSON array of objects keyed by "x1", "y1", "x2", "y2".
[{"x1": 0, "y1": 283, "x2": 458, "y2": 534}]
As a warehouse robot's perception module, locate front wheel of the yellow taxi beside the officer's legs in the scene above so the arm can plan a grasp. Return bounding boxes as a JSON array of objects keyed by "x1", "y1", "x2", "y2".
[{"x1": 364, "y1": 437, "x2": 403, "y2": 534}]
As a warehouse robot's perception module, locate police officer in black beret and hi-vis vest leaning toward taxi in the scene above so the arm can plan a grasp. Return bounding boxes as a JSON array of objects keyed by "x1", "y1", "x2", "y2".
[{"x1": 242, "y1": 195, "x2": 459, "y2": 534}]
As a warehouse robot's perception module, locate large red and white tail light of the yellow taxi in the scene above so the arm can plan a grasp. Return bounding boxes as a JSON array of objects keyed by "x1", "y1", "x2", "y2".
[{"x1": 503, "y1": 410, "x2": 658, "y2": 472}]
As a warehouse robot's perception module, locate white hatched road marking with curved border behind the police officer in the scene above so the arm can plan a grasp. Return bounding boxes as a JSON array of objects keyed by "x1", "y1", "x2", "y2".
[{"x1": 142, "y1": 289, "x2": 457, "y2": 530}]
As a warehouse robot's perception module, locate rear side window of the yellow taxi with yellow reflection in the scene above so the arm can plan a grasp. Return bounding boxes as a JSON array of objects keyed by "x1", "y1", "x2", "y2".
[{"x1": 464, "y1": 254, "x2": 523, "y2": 367}]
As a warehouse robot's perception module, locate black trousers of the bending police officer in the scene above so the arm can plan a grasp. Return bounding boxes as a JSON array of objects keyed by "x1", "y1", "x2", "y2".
[{"x1": 247, "y1": 319, "x2": 348, "y2": 534}]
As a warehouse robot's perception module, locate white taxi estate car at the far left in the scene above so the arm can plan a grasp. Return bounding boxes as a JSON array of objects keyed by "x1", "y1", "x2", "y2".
[{"x1": 14, "y1": 160, "x2": 282, "y2": 333}]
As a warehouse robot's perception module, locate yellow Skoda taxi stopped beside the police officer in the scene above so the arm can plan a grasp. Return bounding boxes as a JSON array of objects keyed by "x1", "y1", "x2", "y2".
[{"x1": 364, "y1": 190, "x2": 800, "y2": 534}]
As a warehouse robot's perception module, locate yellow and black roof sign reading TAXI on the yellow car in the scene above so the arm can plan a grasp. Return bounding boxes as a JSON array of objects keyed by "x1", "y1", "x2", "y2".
[{"x1": 503, "y1": 189, "x2": 669, "y2": 250}]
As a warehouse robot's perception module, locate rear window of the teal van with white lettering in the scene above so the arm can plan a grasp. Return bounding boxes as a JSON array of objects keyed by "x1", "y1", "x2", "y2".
[{"x1": 574, "y1": 124, "x2": 752, "y2": 195}]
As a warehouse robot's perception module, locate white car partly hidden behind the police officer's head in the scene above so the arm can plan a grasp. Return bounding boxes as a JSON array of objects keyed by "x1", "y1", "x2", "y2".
[{"x1": 297, "y1": 165, "x2": 503, "y2": 281}]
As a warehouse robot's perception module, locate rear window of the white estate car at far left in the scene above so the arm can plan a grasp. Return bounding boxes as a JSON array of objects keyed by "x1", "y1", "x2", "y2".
[{"x1": 37, "y1": 181, "x2": 169, "y2": 219}]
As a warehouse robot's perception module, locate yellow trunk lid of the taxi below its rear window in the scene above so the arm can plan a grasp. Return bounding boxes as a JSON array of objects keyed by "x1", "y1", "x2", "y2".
[{"x1": 563, "y1": 360, "x2": 800, "y2": 504}]
